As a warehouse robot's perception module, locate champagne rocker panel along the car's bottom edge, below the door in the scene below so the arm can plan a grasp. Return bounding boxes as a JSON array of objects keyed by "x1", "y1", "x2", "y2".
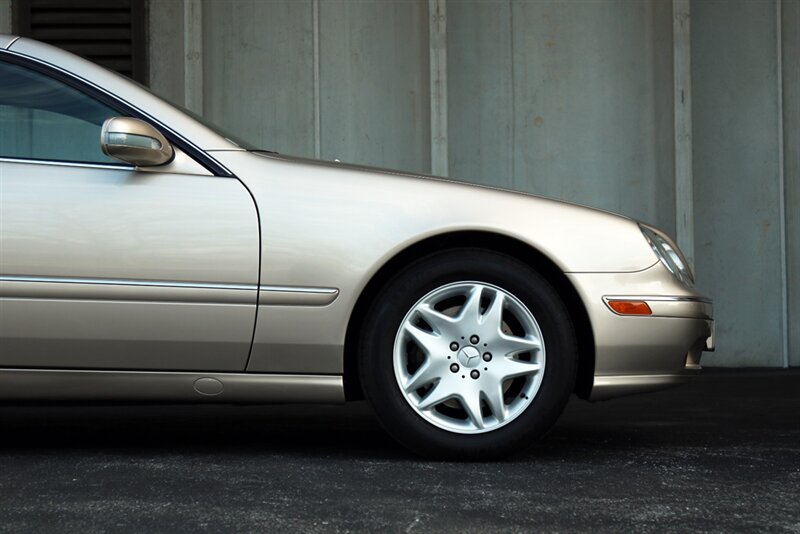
[{"x1": 0, "y1": 369, "x2": 345, "y2": 404}]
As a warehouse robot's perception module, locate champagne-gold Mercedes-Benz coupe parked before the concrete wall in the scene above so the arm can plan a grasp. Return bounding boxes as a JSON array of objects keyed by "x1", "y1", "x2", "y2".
[{"x1": 0, "y1": 35, "x2": 714, "y2": 459}]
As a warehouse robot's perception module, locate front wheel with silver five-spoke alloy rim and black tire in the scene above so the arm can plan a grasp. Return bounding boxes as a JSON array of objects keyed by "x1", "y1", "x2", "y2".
[{"x1": 359, "y1": 249, "x2": 577, "y2": 459}]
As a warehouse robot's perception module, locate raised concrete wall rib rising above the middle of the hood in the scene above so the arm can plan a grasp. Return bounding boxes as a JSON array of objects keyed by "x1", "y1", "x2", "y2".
[{"x1": 428, "y1": 0, "x2": 449, "y2": 176}]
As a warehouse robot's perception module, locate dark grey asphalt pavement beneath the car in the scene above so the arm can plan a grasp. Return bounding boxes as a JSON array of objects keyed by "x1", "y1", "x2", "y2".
[{"x1": 0, "y1": 370, "x2": 800, "y2": 533}]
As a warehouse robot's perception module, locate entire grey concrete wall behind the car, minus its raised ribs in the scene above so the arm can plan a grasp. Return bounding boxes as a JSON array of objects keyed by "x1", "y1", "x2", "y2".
[{"x1": 141, "y1": 0, "x2": 800, "y2": 366}]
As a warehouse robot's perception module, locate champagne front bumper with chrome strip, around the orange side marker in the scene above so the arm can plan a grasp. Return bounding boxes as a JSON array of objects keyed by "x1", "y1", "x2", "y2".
[{"x1": 568, "y1": 265, "x2": 715, "y2": 400}]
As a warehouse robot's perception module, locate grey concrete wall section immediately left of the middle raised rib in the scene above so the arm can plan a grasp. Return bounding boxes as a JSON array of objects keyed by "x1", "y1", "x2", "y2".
[{"x1": 319, "y1": 0, "x2": 430, "y2": 172}]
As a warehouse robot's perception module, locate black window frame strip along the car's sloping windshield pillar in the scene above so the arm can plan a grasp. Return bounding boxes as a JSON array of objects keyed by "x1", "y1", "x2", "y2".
[{"x1": 0, "y1": 49, "x2": 235, "y2": 178}]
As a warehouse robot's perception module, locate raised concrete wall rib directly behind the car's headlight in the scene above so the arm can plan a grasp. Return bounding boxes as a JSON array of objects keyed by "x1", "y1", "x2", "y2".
[{"x1": 672, "y1": 0, "x2": 695, "y2": 266}]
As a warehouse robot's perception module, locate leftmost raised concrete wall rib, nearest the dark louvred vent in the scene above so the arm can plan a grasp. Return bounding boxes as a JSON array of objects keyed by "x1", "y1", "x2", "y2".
[{"x1": 183, "y1": 0, "x2": 204, "y2": 115}]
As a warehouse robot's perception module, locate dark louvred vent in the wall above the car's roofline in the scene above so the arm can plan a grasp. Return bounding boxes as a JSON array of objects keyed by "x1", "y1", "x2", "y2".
[{"x1": 13, "y1": 0, "x2": 147, "y2": 83}]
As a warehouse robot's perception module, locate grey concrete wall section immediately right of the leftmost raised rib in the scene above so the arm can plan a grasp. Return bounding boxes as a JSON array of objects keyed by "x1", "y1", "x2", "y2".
[{"x1": 203, "y1": 0, "x2": 314, "y2": 156}]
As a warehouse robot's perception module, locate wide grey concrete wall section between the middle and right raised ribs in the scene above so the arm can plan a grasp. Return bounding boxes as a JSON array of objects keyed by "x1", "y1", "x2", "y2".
[{"x1": 448, "y1": 1, "x2": 675, "y2": 234}]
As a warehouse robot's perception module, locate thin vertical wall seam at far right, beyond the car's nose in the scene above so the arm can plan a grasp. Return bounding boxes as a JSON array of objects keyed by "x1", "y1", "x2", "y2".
[{"x1": 775, "y1": 0, "x2": 789, "y2": 368}]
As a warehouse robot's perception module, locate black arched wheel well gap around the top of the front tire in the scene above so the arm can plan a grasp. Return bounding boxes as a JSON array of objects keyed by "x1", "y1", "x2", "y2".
[{"x1": 344, "y1": 232, "x2": 595, "y2": 400}]
